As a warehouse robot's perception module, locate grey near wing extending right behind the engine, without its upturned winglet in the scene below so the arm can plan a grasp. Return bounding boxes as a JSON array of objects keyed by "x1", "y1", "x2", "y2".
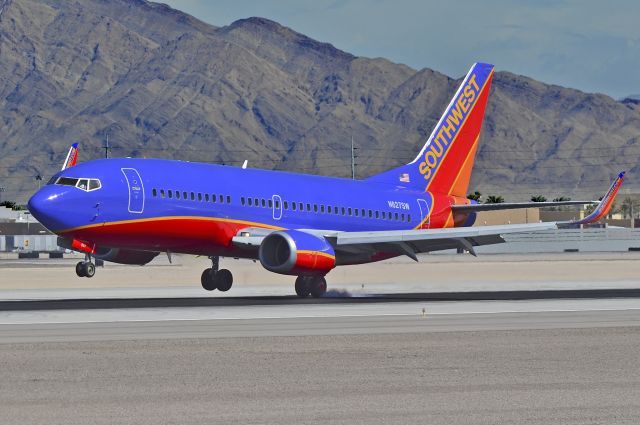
[{"x1": 325, "y1": 223, "x2": 558, "y2": 261}]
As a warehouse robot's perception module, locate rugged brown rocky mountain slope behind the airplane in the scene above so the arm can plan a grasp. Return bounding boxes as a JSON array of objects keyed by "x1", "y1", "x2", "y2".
[{"x1": 0, "y1": 0, "x2": 640, "y2": 202}]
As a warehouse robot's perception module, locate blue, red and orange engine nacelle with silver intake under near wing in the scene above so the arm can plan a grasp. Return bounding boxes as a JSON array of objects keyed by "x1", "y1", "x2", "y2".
[{"x1": 259, "y1": 230, "x2": 336, "y2": 276}]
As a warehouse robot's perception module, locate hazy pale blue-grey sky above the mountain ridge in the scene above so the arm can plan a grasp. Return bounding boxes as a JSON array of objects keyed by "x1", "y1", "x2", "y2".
[{"x1": 166, "y1": 0, "x2": 640, "y2": 98}]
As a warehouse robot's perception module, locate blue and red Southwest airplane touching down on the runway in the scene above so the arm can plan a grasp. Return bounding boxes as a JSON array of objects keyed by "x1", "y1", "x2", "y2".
[{"x1": 29, "y1": 63, "x2": 624, "y2": 297}]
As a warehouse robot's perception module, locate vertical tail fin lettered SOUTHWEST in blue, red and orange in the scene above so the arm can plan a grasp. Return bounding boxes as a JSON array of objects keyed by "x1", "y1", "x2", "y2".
[{"x1": 367, "y1": 63, "x2": 493, "y2": 197}]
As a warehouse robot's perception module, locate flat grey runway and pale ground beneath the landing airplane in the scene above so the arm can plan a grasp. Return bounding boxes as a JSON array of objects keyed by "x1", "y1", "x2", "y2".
[{"x1": 0, "y1": 252, "x2": 640, "y2": 424}]
